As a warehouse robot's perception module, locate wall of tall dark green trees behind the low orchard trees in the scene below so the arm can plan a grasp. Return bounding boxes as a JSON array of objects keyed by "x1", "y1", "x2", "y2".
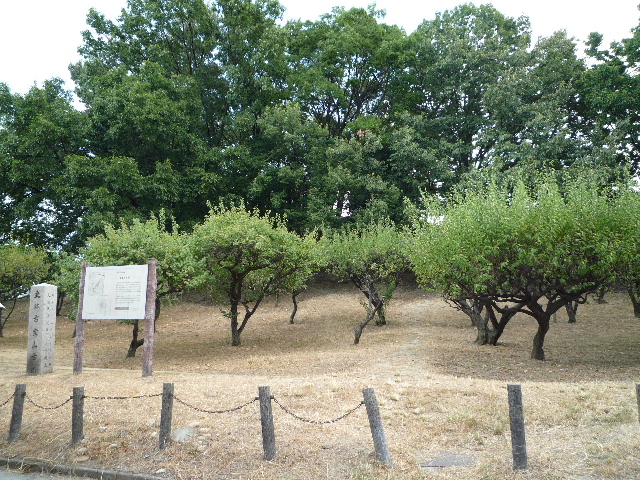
[{"x1": 0, "y1": 0, "x2": 640, "y2": 252}]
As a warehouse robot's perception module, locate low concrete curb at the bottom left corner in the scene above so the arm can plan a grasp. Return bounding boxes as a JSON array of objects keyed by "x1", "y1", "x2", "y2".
[{"x1": 0, "y1": 457, "x2": 167, "y2": 480}]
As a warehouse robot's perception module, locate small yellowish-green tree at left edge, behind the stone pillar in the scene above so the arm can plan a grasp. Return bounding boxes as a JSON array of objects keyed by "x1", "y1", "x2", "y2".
[{"x1": 0, "y1": 245, "x2": 50, "y2": 338}]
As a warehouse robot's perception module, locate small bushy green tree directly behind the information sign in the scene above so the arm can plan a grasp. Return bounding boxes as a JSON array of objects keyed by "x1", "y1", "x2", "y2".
[{"x1": 54, "y1": 212, "x2": 196, "y2": 357}]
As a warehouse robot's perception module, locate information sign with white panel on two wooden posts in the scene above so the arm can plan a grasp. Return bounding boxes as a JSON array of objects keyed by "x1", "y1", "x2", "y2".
[{"x1": 73, "y1": 258, "x2": 158, "y2": 377}]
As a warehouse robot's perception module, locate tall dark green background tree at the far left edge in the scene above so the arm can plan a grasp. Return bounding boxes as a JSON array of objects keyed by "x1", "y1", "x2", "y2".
[{"x1": 0, "y1": 79, "x2": 87, "y2": 248}]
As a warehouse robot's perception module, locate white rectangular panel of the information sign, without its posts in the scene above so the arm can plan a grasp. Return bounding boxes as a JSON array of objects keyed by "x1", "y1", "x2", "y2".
[{"x1": 82, "y1": 265, "x2": 149, "y2": 320}]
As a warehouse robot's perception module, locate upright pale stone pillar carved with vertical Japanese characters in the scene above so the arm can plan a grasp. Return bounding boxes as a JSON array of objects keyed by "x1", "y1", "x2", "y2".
[{"x1": 27, "y1": 283, "x2": 58, "y2": 375}]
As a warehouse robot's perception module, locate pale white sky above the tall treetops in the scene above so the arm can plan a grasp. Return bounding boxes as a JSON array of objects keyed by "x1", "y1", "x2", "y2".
[{"x1": 0, "y1": 0, "x2": 640, "y2": 94}]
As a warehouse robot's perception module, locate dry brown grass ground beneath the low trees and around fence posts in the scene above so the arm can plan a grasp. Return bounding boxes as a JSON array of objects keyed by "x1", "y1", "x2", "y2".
[{"x1": 0, "y1": 283, "x2": 640, "y2": 480}]
